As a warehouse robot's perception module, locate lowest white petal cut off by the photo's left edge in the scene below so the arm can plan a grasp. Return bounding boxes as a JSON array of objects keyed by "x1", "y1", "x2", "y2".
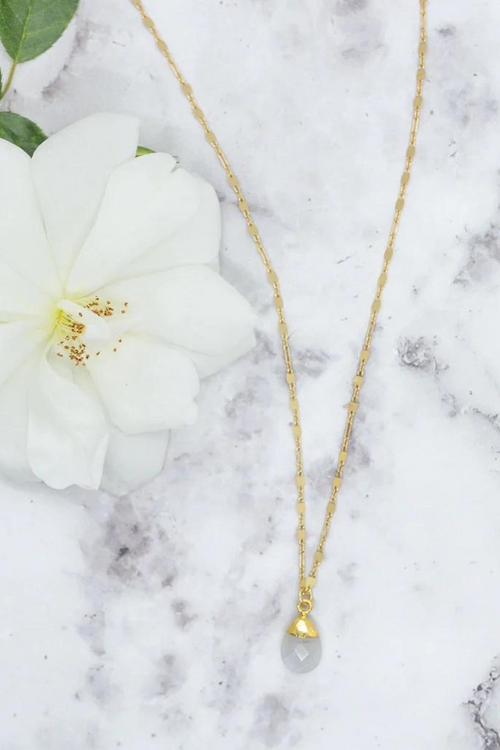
[{"x1": 0, "y1": 357, "x2": 39, "y2": 482}]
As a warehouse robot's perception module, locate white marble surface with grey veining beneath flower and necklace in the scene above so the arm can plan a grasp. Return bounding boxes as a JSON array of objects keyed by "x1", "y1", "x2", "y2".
[{"x1": 0, "y1": 0, "x2": 500, "y2": 750}]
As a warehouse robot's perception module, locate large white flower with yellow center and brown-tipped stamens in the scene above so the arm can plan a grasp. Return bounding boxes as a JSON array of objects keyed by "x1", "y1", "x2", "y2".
[{"x1": 0, "y1": 114, "x2": 254, "y2": 492}]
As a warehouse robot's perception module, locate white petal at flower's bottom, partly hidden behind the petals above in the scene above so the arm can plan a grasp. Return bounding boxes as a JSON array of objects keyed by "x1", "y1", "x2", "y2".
[{"x1": 101, "y1": 428, "x2": 169, "y2": 496}]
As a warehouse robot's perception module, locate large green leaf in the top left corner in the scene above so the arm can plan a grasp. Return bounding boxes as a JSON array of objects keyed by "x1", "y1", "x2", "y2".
[{"x1": 0, "y1": 0, "x2": 78, "y2": 63}]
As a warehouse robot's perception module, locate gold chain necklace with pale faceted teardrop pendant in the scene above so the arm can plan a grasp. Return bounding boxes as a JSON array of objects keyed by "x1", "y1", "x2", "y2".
[{"x1": 132, "y1": 0, "x2": 428, "y2": 672}]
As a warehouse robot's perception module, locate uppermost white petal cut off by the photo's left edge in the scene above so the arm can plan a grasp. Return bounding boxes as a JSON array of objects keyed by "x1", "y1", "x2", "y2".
[{"x1": 0, "y1": 140, "x2": 58, "y2": 295}]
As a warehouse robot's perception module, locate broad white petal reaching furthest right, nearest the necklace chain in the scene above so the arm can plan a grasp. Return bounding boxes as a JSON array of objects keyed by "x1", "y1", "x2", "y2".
[{"x1": 102, "y1": 265, "x2": 255, "y2": 374}]
